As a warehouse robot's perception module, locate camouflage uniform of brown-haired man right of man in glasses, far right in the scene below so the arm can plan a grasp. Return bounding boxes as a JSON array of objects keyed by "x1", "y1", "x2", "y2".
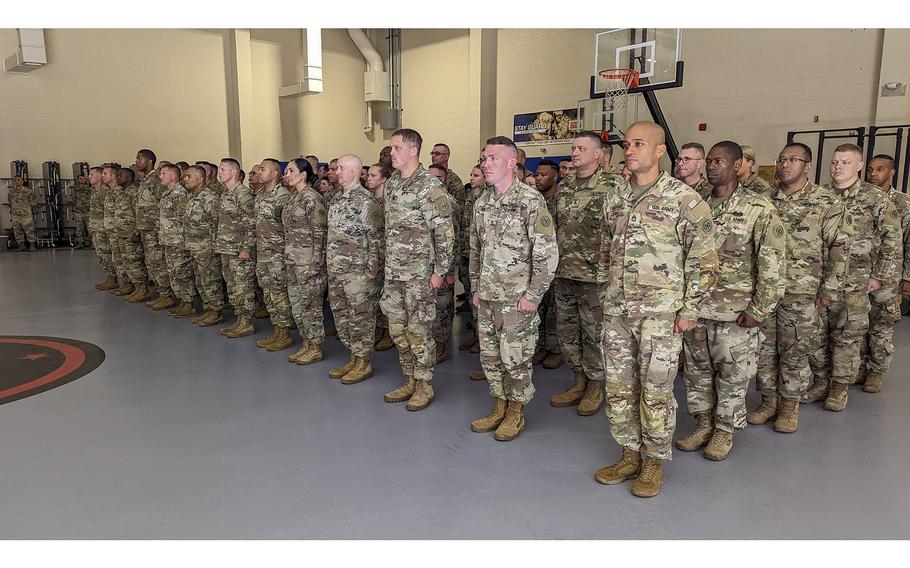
[{"x1": 810, "y1": 180, "x2": 903, "y2": 384}]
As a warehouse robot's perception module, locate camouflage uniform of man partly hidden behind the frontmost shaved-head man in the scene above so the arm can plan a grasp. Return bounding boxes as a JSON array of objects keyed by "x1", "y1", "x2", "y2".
[{"x1": 553, "y1": 167, "x2": 625, "y2": 381}]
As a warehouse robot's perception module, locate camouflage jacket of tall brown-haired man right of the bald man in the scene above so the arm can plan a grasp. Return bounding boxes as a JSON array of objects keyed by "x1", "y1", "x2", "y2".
[{"x1": 385, "y1": 166, "x2": 455, "y2": 281}]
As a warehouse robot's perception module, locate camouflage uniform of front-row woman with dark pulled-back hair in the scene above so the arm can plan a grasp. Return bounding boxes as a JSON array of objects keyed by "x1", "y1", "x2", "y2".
[{"x1": 281, "y1": 187, "x2": 330, "y2": 347}]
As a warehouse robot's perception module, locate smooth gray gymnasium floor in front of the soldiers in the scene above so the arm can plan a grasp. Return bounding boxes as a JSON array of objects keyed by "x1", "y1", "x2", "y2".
[{"x1": 0, "y1": 250, "x2": 910, "y2": 539}]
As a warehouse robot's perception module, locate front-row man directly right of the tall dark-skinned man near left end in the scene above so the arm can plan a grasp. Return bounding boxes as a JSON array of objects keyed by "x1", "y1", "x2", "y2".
[{"x1": 158, "y1": 164, "x2": 196, "y2": 318}]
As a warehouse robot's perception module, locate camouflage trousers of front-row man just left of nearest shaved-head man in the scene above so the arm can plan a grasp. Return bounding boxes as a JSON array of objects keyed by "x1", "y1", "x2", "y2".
[{"x1": 477, "y1": 300, "x2": 540, "y2": 404}]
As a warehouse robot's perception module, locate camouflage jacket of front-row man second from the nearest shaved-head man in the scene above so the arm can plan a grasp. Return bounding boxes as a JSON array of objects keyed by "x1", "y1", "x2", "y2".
[{"x1": 470, "y1": 180, "x2": 559, "y2": 304}]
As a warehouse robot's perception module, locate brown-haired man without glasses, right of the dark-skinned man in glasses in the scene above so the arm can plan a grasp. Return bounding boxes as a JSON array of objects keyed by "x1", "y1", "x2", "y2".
[{"x1": 803, "y1": 144, "x2": 903, "y2": 411}]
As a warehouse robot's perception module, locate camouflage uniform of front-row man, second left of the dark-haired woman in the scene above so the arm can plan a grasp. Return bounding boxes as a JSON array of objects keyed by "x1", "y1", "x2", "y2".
[{"x1": 215, "y1": 182, "x2": 256, "y2": 318}]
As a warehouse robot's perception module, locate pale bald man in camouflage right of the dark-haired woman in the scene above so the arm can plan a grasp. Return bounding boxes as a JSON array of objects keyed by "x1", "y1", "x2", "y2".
[{"x1": 326, "y1": 154, "x2": 383, "y2": 385}]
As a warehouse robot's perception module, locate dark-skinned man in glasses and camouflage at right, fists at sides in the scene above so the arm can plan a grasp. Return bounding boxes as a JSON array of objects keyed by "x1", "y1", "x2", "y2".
[{"x1": 746, "y1": 143, "x2": 848, "y2": 433}]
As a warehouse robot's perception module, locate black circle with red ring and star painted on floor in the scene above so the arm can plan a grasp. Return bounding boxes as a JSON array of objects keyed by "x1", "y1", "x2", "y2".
[{"x1": 0, "y1": 335, "x2": 104, "y2": 404}]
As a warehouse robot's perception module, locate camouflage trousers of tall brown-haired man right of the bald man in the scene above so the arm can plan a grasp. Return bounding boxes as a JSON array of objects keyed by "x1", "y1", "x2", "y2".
[{"x1": 379, "y1": 278, "x2": 436, "y2": 381}]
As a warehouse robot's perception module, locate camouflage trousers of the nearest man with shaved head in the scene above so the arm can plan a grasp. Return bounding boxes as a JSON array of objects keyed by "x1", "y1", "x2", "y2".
[{"x1": 603, "y1": 313, "x2": 682, "y2": 460}]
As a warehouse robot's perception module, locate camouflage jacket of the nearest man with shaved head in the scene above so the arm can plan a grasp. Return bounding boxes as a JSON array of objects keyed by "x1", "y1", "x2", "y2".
[{"x1": 597, "y1": 172, "x2": 718, "y2": 320}]
